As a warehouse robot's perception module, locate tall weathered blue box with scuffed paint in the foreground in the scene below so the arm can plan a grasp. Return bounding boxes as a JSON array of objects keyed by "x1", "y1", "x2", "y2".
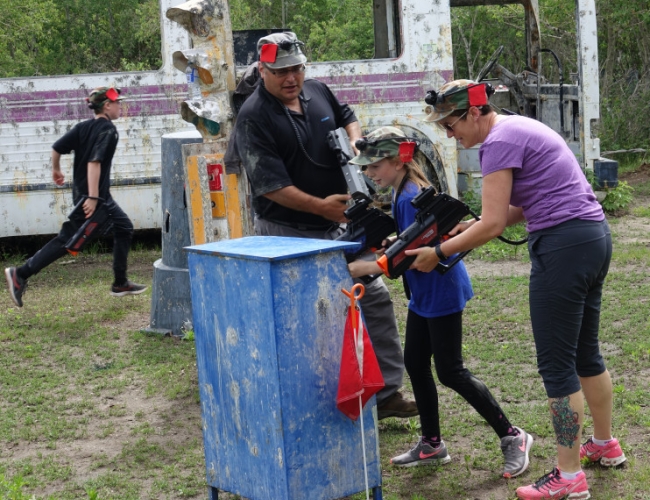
[{"x1": 186, "y1": 237, "x2": 381, "y2": 500}]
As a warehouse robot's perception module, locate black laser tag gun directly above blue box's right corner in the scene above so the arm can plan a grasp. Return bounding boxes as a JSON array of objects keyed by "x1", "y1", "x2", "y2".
[{"x1": 336, "y1": 191, "x2": 395, "y2": 263}]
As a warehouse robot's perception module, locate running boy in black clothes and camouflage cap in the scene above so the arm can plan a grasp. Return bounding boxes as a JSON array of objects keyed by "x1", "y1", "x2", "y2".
[{"x1": 5, "y1": 87, "x2": 147, "y2": 307}]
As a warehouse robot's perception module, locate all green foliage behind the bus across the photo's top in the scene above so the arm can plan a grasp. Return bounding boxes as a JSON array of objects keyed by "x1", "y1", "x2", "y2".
[{"x1": 0, "y1": 0, "x2": 650, "y2": 156}]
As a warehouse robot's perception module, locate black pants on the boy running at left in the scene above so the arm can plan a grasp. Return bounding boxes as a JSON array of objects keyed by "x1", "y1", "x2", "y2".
[{"x1": 19, "y1": 198, "x2": 133, "y2": 285}]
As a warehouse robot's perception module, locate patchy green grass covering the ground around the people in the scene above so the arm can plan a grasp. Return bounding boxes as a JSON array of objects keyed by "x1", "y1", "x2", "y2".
[{"x1": 0, "y1": 201, "x2": 650, "y2": 500}]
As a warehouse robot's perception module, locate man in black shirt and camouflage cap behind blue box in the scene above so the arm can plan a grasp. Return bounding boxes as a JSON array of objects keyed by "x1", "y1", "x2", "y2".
[{"x1": 235, "y1": 32, "x2": 418, "y2": 419}]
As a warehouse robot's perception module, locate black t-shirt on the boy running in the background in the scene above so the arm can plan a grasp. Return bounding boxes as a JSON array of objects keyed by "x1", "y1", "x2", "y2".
[{"x1": 52, "y1": 118, "x2": 119, "y2": 203}]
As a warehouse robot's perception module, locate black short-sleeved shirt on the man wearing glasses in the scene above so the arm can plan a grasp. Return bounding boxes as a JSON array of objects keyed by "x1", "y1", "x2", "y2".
[{"x1": 236, "y1": 80, "x2": 357, "y2": 227}]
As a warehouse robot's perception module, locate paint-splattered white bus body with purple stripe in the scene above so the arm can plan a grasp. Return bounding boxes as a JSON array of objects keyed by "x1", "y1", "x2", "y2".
[{"x1": 0, "y1": 0, "x2": 600, "y2": 238}]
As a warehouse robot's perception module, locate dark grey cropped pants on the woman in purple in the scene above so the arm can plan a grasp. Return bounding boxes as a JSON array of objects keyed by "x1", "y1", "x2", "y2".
[{"x1": 528, "y1": 219, "x2": 612, "y2": 398}]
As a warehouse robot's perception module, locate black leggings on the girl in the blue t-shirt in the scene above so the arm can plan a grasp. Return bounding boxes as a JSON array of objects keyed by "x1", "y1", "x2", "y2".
[{"x1": 404, "y1": 310, "x2": 511, "y2": 438}]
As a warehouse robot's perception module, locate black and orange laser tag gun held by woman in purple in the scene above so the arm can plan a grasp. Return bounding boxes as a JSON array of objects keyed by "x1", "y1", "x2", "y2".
[{"x1": 377, "y1": 186, "x2": 471, "y2": 278}]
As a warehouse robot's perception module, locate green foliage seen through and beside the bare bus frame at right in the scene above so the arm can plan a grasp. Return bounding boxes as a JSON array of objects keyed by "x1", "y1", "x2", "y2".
[{"x1": 451, "y1": 0, "x2": 650, "y2": 150}]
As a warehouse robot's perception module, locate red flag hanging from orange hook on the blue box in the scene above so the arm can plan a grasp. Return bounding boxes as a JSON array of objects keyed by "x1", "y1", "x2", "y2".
[{"x1": 336, "y1": 302, "x2": 384, "y2": 420}]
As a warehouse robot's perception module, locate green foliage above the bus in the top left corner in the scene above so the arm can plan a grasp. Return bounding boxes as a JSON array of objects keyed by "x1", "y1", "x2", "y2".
[{"x1": 0, "y1": 0, "x2": 162, "y2": 78}]
